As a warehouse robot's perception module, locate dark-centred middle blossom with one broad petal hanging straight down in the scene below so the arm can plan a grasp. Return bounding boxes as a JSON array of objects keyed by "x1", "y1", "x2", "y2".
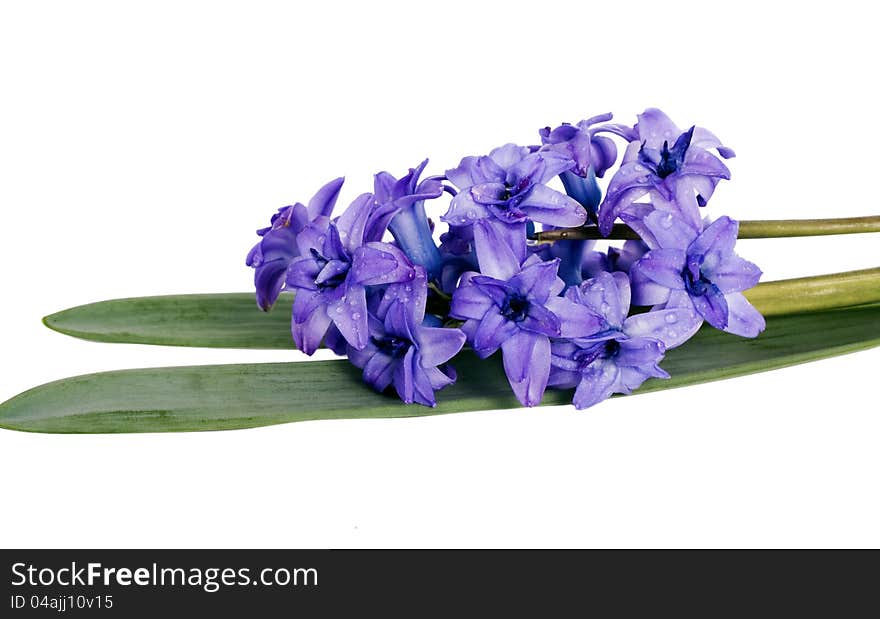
[{"x1": 449, "y1": 221, "x2": 599, "y2": 406}]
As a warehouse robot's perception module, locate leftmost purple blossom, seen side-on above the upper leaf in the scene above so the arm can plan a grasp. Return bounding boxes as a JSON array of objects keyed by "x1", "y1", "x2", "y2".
[{"x1": 246, "y1": 178, "x2": 345, "y2": 311}]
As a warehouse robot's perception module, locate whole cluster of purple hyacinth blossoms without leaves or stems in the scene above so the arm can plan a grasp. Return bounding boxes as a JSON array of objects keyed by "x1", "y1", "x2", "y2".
[{"x1": 247, "y1": 109, "x2": 764, "y2": 408}]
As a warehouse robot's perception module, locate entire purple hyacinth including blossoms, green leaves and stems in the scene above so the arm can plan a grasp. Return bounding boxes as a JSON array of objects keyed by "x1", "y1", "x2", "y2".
[{"x1": 17, "y1": 109, "x2": 880, "y2": 432}]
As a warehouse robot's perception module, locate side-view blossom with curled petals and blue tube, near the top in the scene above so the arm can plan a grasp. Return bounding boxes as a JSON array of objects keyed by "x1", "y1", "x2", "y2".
[{"x1": 538, "y1": 114, "x2": 635, "y2": 218}]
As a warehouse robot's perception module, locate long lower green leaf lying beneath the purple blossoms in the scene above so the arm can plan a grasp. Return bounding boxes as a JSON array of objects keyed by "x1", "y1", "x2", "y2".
[{"x1": 6, "y1": 306, "x2": 880, "y2": 433}]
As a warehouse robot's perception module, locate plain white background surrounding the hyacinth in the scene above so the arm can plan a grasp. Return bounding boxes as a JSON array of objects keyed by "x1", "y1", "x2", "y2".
[{"x1": 0, "y1": 0, "x2": 880, "y2": 548}]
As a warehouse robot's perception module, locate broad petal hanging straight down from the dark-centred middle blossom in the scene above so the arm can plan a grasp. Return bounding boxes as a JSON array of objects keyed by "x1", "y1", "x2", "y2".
[{"x1": 501, "y1": 331, "x2": 550, "y2": 406}]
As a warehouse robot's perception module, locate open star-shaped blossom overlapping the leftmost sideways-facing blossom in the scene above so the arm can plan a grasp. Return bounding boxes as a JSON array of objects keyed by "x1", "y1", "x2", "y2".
[{"x1": 287, "y1": 193, "x2": 415, "y2": 355}]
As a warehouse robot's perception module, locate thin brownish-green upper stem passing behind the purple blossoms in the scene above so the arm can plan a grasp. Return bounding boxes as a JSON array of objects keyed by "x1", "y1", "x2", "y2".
[{"x1": 532, "y1": 215, "x2": 880, "y2": 243}]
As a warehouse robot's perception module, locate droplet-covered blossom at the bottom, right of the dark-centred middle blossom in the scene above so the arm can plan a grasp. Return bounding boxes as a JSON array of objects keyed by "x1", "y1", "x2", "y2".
[{"x1": 549, "y1": 272, "x2": 693, "y2": 409}]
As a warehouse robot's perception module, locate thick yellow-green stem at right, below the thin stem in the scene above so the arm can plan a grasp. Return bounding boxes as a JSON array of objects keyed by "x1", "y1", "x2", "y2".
[{"x1": 745, "y1": 268, "x2": 880, "y2": 316}]
